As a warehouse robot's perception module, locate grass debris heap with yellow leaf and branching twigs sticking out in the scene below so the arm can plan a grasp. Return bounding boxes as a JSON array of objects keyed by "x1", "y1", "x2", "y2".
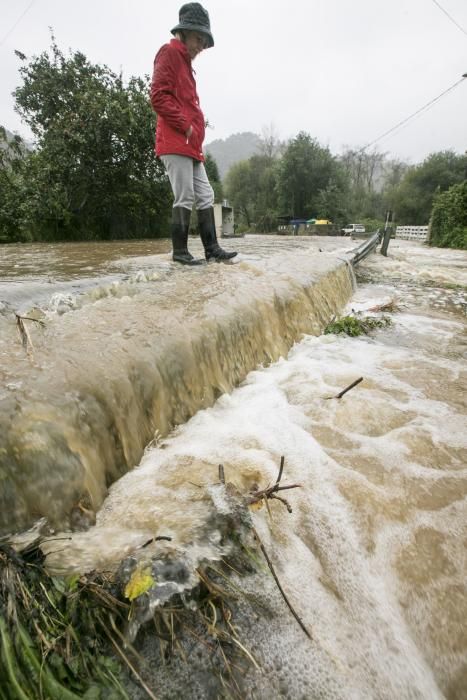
[{"x1": 0, "y1": 458, "x2": 304, "y2": 700}]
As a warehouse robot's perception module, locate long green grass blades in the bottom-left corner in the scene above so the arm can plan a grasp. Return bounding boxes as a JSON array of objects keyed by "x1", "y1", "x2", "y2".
[{"x1": 0, "y1": 543, "x2": 128, "y2": 700}]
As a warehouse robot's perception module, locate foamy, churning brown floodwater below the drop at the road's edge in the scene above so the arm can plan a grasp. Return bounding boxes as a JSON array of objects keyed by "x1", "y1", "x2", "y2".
[{"x1": 1, "y1": 241, "x2": 467, "y2": 700}]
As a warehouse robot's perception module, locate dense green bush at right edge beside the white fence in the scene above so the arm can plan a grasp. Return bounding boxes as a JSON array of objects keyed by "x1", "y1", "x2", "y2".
[{"x1": 430, "y1": 180, "x2": 467, "y2": 250}]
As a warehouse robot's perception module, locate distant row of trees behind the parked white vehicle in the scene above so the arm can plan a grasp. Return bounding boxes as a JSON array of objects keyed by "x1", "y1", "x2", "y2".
[{"x1": 225, "y1": 132, "x2": 467, "y2": 247}]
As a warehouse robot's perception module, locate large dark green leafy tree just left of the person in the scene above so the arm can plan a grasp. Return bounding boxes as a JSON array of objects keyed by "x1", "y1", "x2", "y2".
[{"x1": 15, "y1": 37, "x2": 171, "y2": 239}]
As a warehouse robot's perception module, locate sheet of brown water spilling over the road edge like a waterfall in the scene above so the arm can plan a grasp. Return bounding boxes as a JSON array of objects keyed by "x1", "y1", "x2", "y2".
[{"x1": 0, "y1": 237, "x2": 352, "y2": 531}]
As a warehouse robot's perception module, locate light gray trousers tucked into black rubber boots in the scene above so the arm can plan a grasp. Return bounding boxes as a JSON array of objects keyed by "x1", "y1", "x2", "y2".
[{"x1": 160, "y1": 154, "x2": 214, "y2": 211}]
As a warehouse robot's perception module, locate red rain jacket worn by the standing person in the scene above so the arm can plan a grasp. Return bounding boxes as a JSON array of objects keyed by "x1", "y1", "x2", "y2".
[{"x1": 151, "y1": 39, "x2": 205, "y2": 161}]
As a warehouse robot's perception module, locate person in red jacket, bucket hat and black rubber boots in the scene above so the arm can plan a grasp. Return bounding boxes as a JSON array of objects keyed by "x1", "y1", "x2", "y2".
[{"x1": 151, "y1": 2, "x2": 237, "y2": 265}]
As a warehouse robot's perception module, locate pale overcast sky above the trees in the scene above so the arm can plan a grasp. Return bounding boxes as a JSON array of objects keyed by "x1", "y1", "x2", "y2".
[{"x1": 0, "y1": 0, "x2": 467, "y2": 162}]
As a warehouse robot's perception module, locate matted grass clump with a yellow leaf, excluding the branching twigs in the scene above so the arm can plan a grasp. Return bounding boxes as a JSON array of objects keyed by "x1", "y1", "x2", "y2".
[{"x1": 0, "y1": 528, "x2": 258, "y2": 700}]
